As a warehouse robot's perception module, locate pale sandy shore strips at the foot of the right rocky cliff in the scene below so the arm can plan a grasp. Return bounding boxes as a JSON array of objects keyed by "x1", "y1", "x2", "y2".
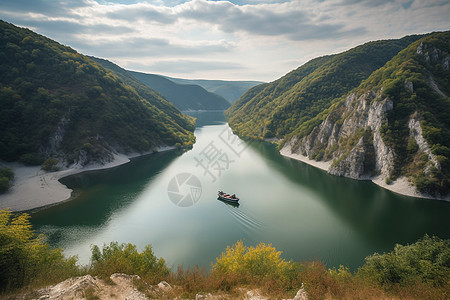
[{"x1": 280, "y1": 147, "x2": 450, "y2": 201}]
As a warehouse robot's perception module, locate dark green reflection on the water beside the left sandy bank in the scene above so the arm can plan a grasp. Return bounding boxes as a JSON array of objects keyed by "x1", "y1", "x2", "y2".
[{"x1": 32, "y1": 150, "x2": 183, "y2": 227}]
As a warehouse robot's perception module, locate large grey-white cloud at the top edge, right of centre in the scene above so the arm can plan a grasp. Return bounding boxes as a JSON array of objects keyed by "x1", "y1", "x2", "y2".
[{"x1": 177, "y1": 0, "x2": 367, "y2": 40}]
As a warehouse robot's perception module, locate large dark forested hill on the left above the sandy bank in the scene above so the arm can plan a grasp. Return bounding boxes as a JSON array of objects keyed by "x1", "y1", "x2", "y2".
[{"x1": 0, "y1": 21, "x2": 194, "y2": 164}]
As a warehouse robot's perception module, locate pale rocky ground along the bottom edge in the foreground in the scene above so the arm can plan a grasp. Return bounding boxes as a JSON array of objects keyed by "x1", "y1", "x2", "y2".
[{"x1": 9, "y1": 274, "x2": 308, "y2": 300}]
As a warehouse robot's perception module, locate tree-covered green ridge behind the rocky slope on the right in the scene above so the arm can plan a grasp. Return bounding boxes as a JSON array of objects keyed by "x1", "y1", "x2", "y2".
[{"x1": 227, "y1": 36, "x2": 420, "y2": 138}]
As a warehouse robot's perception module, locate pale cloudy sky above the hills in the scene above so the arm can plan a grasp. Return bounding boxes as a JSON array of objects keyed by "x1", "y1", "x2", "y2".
[{"x1": 0, "y1": 0, "x2": 450, "y2": 82}]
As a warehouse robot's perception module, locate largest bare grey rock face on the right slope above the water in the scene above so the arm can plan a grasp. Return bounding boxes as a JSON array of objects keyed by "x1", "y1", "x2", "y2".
[{"x1": 282, "y1": 92, "x2": 394, "y2": 179}]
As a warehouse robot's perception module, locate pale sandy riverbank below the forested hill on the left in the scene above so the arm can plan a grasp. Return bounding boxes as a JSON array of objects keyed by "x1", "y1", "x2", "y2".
[{"x1": 0, "y1": 147, "x2": 175, "y2": 212}]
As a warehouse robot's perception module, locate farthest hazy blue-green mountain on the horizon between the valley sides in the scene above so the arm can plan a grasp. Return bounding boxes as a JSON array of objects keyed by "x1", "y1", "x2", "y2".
[{"x1": 166, "y1": 77, "x2": 263, "y2": 104}]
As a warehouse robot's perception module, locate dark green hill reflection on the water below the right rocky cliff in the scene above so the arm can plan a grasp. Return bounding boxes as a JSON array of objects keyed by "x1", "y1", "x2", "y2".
[{"x1": 246, "y1": 142, "x2": 450, "y2": 251}]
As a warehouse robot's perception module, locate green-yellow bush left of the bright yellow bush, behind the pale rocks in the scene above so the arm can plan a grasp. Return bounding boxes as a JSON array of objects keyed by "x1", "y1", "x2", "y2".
[{"x1": 91, "y1": 242, "x2": 169, "y2": 283}]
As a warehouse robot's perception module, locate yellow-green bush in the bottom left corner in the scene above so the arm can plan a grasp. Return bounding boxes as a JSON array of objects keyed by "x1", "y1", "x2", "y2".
[{"x1": 0, "y1": 210, "x2": 80, "y2": 292}]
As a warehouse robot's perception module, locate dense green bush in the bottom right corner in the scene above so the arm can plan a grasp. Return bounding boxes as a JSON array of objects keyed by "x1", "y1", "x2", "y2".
[{"x1": 358, "y1": 235, "x2": 450, "y2": 287}]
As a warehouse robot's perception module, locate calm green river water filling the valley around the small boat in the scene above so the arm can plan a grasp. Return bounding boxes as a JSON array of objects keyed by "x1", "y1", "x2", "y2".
[{"x1": 32, "y1": 113, "x2": 450, "y2": 269}]
